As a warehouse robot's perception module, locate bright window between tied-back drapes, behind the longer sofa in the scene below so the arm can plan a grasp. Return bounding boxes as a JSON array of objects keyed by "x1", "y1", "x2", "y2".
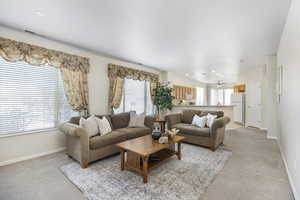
[{"x1": 114, "y1": 79, "x2": 154, "y2": 114}]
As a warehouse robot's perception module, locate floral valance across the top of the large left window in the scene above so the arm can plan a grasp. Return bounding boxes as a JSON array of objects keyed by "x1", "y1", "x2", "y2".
[{"x1": 0, "y1": 37, "x2": 90, "y2": 73}]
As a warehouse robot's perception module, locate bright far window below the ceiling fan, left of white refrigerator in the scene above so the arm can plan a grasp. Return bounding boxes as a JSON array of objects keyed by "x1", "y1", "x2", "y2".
[{"x1": 210, "y1": 88, "x2": 233, "y2": 105}]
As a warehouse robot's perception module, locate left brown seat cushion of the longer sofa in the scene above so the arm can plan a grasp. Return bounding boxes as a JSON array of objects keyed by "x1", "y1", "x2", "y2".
[{"x1": 90, "y1": 131, "x2": 127, "y2": 149}]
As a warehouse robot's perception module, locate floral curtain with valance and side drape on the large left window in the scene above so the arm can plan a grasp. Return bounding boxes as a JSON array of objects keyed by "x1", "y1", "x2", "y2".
[{"x1": 0, "y1": 37, "x2": 90, "y2": 112}]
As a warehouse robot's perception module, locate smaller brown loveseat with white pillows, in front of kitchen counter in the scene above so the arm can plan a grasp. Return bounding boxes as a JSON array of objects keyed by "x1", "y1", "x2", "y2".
[{"x1": 166, "y1": 110, "x2": 230, "y2": 151}]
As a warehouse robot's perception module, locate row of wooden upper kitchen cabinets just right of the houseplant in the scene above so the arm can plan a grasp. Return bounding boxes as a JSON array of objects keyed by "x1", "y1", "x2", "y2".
[{"x1": 173, "y1": 85, "x2": 197, "y2": 100}]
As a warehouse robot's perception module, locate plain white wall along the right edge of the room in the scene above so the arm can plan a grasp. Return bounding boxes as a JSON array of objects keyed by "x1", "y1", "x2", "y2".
[{"x1": 277, "y1": 0, "x2": 300, "y2": 200}]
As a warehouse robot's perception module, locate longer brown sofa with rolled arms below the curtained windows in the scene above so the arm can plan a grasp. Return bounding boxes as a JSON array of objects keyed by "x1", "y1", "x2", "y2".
[{"x1": 60, "y1": 113, "x2": 154, "y2": 168}]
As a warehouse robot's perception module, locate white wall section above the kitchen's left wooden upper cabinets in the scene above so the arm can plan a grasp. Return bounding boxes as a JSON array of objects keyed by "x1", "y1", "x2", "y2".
[{"x1": 162, "y1": 72, "x2": 207, "y2": 105}]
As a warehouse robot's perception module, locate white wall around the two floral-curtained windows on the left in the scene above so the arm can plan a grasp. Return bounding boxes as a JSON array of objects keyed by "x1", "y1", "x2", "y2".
[{"x1": 0, "y1": 27, "x2": 161, "y2": 165}]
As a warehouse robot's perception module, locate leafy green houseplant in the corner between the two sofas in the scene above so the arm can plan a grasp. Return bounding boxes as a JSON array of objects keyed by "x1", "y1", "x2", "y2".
[{"x1": 153, "y1": 82, "x2": 175, "y2": 119}]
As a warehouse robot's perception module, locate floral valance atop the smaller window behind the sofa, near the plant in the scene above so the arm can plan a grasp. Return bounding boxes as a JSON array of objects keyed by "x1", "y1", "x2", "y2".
[{"x1": 108, "y1": 64, "x2": 159, "y2": 82}]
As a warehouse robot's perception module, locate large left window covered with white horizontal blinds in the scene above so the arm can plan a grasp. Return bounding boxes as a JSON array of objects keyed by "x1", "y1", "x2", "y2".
[{"x1": 0, "y1": 58, "x2": 79, "y2": 135}]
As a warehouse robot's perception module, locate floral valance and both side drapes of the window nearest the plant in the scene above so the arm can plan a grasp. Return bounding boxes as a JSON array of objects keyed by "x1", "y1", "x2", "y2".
[{"x1": 108, "y1": 64, "x2": 159, "y2": 113}]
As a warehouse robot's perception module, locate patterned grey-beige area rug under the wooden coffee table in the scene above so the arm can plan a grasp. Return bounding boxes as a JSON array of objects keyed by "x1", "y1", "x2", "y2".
[{"x1": 61, "y1": 144, "x2": 231, "y2": 200}]
